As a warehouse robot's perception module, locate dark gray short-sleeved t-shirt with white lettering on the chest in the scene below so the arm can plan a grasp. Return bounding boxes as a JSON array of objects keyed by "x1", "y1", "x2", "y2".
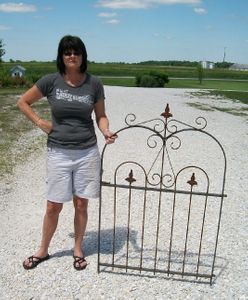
[{"x1": 36, "y1": 73, "x2": 105, "y2": 149}]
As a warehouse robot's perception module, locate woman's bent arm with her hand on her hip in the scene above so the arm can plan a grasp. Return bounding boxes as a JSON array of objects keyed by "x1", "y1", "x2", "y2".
[{"x1": 17, "y1": 85, "x2": 52, "y2": 133}]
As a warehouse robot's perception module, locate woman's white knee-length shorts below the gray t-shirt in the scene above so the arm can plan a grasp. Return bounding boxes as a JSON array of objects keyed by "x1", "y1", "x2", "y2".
[{"x1": 47, "y1": 145, "x2": 101, "y2": 203}]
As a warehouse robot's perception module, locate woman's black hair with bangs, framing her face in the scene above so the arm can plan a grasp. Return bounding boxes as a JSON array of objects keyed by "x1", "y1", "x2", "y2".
[{"x1": 57, "y1": 35, "x2": 87, "y2": 74}]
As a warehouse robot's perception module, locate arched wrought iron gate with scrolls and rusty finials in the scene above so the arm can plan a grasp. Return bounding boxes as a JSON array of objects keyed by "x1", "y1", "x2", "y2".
[{"x1": 98, "y1": 104, "x2": 226, "y2": 284}]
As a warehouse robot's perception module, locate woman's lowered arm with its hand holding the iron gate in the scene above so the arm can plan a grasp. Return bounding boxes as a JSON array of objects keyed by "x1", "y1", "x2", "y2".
[{"x1": 94, "y1": 99, "x2": 117, "y2": 144}]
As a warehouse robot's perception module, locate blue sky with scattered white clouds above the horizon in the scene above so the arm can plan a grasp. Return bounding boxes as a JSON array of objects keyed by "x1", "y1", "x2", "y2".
[{"x1": 0, "y1": 0, "x2": 248, "y2": 64}]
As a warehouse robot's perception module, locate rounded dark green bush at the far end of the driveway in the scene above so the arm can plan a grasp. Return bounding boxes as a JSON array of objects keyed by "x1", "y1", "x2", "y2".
[{"x1": 136, "y1": 71, "x2": 169, "y2": 87}]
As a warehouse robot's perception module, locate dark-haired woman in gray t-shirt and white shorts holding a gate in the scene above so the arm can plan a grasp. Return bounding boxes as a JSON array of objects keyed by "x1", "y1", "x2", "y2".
[{"x1": 18, "y1": 35, "x2": 116, "y2": 270}]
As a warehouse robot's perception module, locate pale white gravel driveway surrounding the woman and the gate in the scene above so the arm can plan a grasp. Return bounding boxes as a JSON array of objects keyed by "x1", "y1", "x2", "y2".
[{"x1": 0, "y1": 86, "x2": 248, "y2": 300}]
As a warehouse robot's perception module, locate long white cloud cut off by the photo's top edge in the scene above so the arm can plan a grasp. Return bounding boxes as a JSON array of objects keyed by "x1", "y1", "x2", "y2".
[{"x1": 97, "y1": 0, "x2": 202, "y2": 9}]
